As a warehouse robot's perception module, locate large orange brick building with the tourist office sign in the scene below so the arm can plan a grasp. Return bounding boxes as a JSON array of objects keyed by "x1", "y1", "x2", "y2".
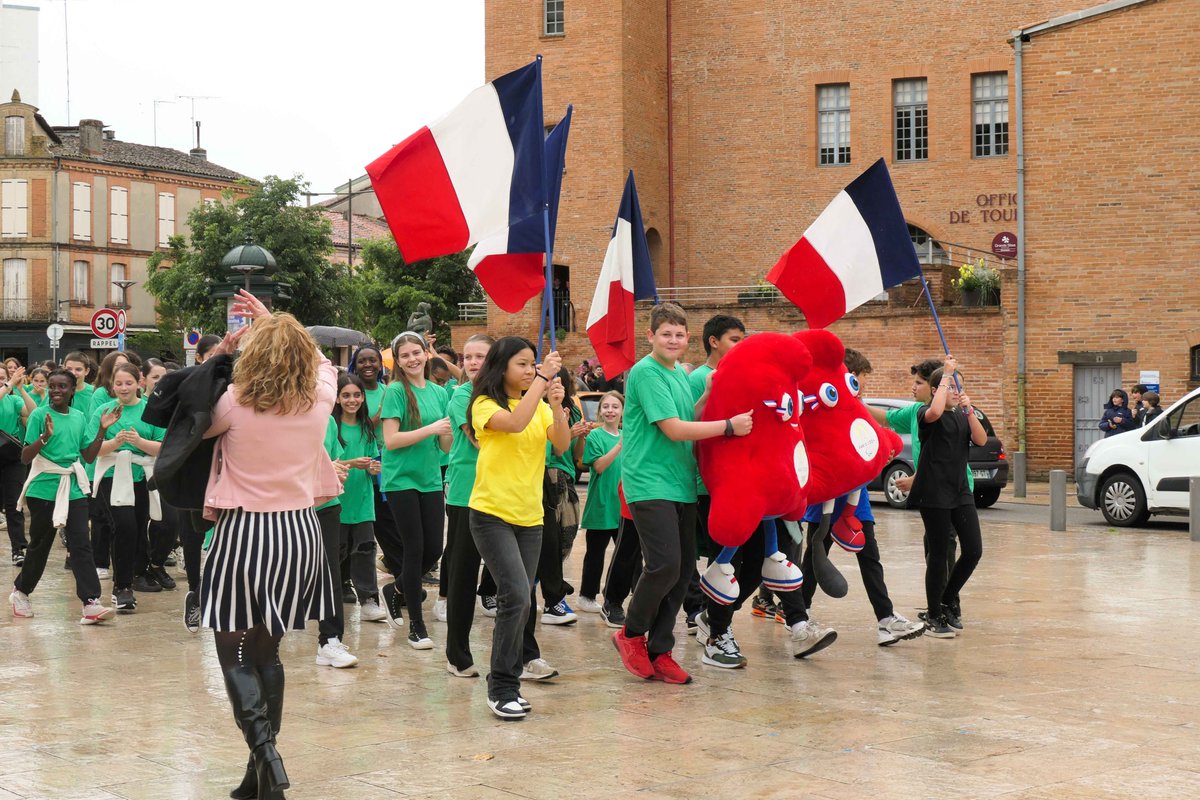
[{"x1": 472, "y1": 0, "x2": 1200, "y2": 474}]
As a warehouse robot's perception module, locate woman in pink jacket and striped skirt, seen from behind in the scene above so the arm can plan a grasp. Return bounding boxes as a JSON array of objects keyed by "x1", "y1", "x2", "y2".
[{"x1": 200, "y1": 291, "x2": 341, "y2": 798}]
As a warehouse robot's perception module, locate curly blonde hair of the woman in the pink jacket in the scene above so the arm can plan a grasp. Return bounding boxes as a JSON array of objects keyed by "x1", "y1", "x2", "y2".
[{"x1": 233, "y1": 313, "x2": 319, "y2": 414}]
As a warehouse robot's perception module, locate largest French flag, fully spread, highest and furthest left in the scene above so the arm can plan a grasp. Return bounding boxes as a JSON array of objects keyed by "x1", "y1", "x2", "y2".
[{"x1": 367, "y1": 56, "x2": 545, "y2": 263}]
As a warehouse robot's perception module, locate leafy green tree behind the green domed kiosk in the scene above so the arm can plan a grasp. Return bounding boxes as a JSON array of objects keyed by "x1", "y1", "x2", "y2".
[{"x1": 146, "y1": 175, "x2": 362, "y2": 338}]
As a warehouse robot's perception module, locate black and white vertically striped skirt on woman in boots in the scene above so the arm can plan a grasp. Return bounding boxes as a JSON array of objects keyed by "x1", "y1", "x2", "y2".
[{"x1": 200, "y1": 509, "x2": 341, "y2": 636}]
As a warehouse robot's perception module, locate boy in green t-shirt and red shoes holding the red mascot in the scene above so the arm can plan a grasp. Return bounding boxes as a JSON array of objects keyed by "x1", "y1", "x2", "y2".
[{"x1": 613, "y1": 302, "x2": 752, "y2": 684}]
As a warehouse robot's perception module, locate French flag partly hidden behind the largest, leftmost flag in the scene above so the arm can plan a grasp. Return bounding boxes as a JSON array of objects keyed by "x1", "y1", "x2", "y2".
[{"x1": 467, "y1": 106, "x2": 571, "y2": 314}]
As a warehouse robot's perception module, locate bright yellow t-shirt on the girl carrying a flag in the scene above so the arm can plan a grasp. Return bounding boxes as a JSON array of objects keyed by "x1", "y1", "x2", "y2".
[{"x1": 468, "y1": 397, "x2": 554, "y2": 528}]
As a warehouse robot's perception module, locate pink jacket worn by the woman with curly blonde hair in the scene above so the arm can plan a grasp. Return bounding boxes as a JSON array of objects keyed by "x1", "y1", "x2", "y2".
[{"x1": 204, "y1": 357, "x2": 342, "y2": 521}]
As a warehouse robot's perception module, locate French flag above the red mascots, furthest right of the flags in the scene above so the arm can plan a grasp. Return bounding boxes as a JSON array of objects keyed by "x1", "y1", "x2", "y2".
[{"x1": 767, "y1": 158, "x2": 920, "y2": 327}]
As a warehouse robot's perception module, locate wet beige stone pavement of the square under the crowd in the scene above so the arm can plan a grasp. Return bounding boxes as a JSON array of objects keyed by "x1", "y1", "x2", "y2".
[{"x1": 0, "y1": 504, "x2": 1200, "y2": 800}]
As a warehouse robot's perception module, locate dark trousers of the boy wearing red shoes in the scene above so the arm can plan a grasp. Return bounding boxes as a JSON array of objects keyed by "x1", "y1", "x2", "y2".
[{"x1": 625, "y1": 500, "x2": 696, "y2": 658}]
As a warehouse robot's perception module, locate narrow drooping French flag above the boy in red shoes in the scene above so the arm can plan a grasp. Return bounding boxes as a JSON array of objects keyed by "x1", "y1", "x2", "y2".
[{"x1": 588, "y1": 170, "x2": 658, "y2": 378}]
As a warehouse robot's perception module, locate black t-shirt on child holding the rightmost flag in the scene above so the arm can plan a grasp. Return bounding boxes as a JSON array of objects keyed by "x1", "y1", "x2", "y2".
[{"x1": 908, "y1": 405, "x2": 974, "y2": 509}]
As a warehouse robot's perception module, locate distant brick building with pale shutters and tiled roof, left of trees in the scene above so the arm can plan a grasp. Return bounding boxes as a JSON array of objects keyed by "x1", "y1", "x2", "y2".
[{"x1": 0, "y1": 92, "x2": 245, "y2": 363}]
